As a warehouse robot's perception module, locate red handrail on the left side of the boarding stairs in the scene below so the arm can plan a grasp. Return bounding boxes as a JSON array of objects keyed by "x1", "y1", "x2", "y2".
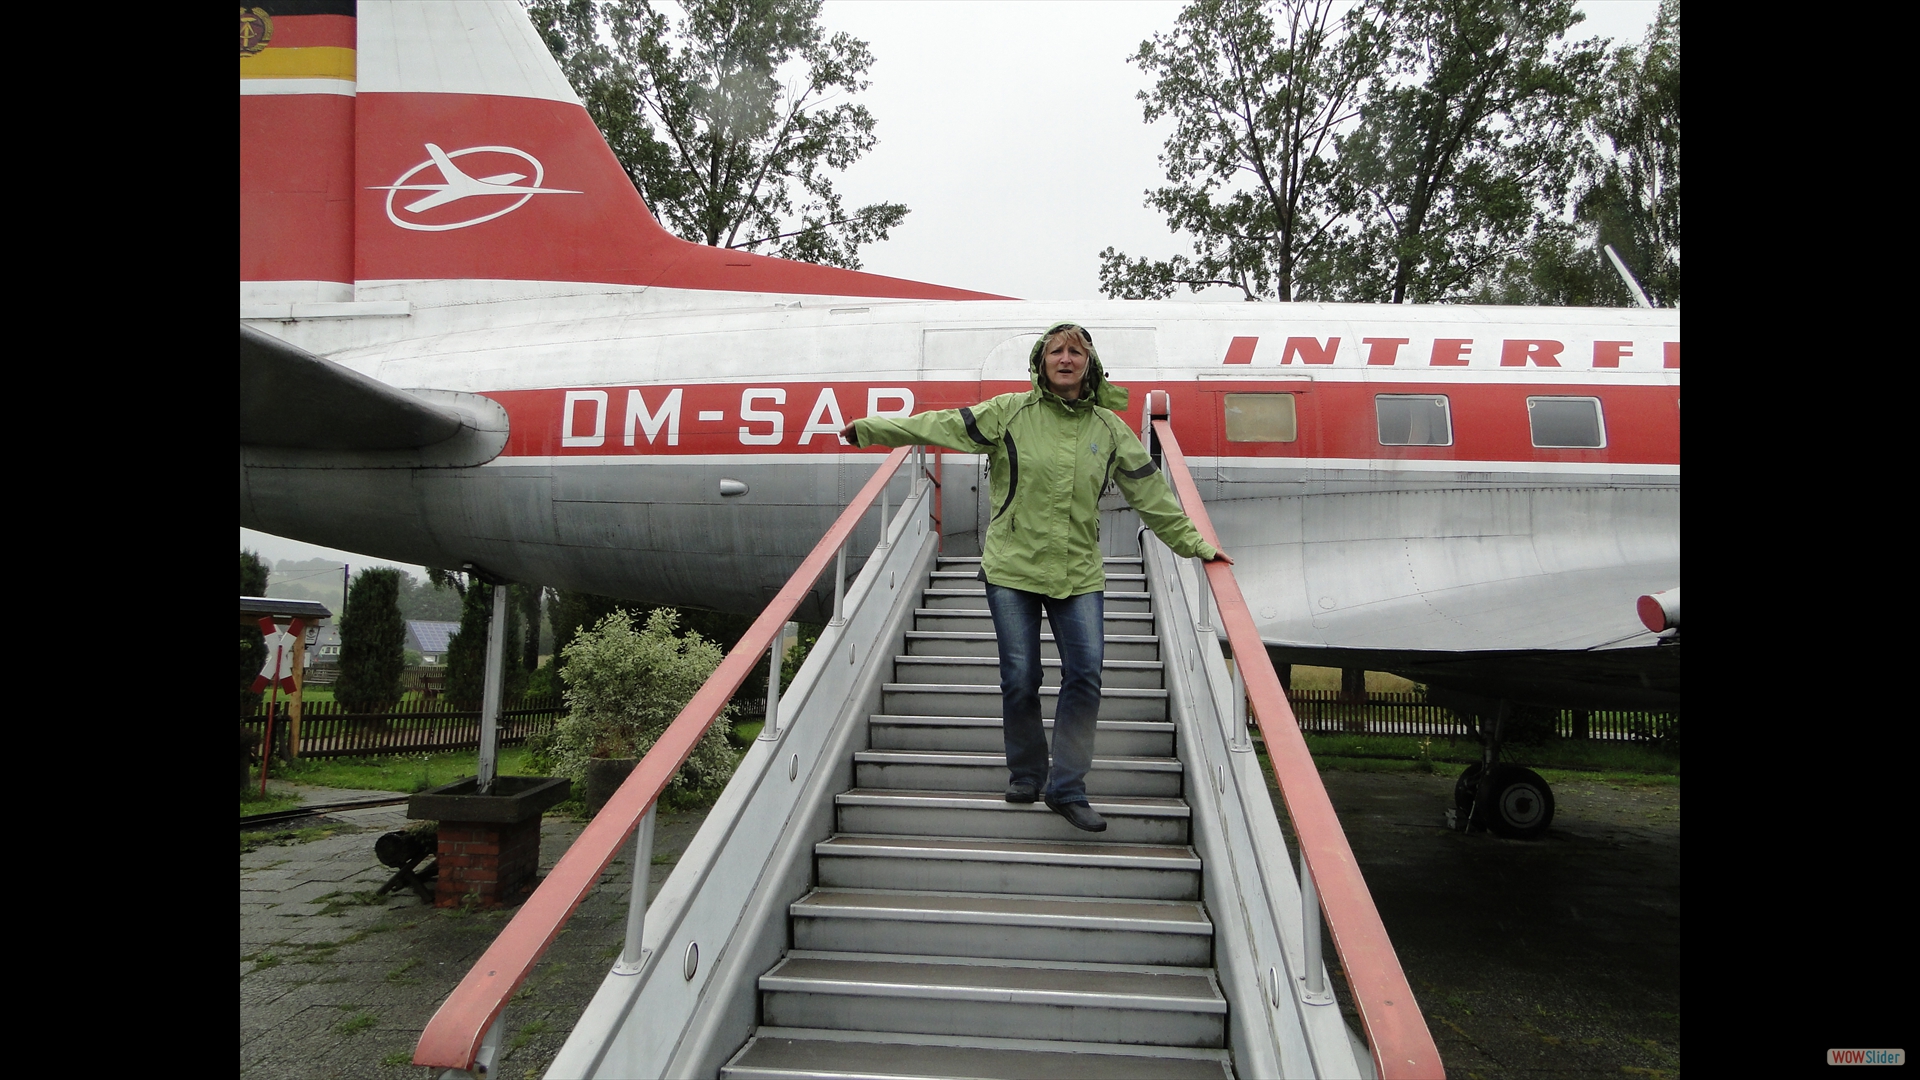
[{"x1": 413, "y1": 446, "x2": 912, "y2": 1070}]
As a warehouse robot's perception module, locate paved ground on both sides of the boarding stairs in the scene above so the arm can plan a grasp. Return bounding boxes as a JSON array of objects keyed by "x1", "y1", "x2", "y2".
[{"x1": 240, "y1": 773, "x2": 1680, "y2": 1080}]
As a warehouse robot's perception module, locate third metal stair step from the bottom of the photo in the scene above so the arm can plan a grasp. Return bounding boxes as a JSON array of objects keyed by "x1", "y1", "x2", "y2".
[{"x1": 787, "y1": 888, "x2": 1213, "y2": 967}]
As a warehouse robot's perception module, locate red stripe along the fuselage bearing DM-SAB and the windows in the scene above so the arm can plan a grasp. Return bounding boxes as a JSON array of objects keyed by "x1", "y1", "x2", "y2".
[{"x1": 488, "y1": 379, "x2": 1680, "y2": 465}]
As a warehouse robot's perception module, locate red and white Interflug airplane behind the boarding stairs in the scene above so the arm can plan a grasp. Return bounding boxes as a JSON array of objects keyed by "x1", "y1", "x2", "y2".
[{"x1": 240, "y1": 0, "x2": 1680, "y2": 834}]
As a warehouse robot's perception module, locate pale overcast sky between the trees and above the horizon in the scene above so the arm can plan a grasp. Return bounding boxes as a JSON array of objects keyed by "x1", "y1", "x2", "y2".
[{"x1": 240, "y1": 0, "x2": 1659, "y2": 578}]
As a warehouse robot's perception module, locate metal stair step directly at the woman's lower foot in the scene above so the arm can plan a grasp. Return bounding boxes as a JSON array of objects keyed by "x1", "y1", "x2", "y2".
[{"x1": 833, "y1": 788, "x2": 1192, "y2": 844}]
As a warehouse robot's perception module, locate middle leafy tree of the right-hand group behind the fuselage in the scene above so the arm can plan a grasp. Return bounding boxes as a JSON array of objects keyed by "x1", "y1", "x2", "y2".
[{"x1": 1317, "y1": 0, "x2": 1605, "y2": 304}]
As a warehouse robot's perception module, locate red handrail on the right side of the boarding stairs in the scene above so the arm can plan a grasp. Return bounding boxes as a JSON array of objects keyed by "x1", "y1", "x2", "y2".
[{"x1": 1154, "y1": 419, "x2": 1446, "y2": 1080}]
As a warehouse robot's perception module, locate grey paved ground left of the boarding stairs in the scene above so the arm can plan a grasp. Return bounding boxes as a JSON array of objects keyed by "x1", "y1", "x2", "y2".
[{"x1": 240, "y1": 786, "x2": 705, "y2": 1080}]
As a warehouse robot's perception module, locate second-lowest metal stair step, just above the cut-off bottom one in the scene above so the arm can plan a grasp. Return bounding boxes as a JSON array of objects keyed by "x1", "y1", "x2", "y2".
[{"x1": 760, "y1": 949, "x2": 1227, "y2": 1049}]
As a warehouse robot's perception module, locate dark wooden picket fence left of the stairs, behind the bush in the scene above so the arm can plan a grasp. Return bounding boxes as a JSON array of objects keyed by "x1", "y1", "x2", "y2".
[{"x1": 240, "y1": 696, "x2": 566, "y2": 757}]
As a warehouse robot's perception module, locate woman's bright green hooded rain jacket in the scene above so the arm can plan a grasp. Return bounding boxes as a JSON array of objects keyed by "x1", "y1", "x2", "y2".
[{"x1": 852, "y1": 323, "x2": 1215, "y2": 598}]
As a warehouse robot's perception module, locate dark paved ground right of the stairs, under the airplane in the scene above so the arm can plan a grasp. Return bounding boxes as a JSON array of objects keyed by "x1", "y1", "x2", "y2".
[{"x1": 1283, "y1": 771, "x2": 1680, "y2": 1080}]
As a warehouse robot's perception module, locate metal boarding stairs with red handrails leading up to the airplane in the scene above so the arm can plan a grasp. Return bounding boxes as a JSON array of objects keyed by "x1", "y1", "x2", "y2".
[{"x1": 413, "y1": 430, "x2": 1444, "y2": 1080}]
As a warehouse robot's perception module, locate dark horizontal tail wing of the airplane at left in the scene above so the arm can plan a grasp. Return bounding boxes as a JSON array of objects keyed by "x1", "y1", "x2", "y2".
[{"x1": 240, "y1": 323, "x2": 463, "y2": 450}]
